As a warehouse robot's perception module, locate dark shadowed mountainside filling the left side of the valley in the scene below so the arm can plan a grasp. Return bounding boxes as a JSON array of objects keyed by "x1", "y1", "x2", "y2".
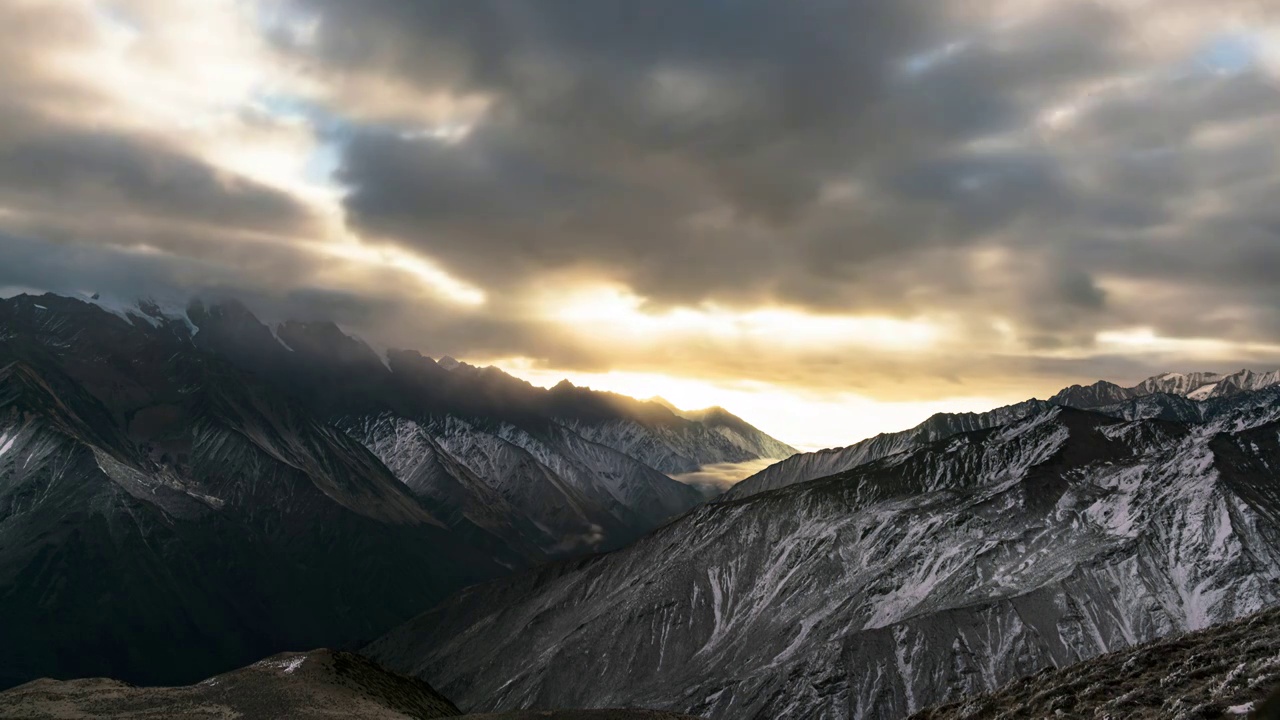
[{"x1": 0, "y1": 295, "x2": 788, "y2": 687}]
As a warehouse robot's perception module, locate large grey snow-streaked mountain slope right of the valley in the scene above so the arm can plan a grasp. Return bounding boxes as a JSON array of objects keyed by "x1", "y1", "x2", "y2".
[{"x1": 366, "y1": 388, "x2": 1280, "y2": 719}]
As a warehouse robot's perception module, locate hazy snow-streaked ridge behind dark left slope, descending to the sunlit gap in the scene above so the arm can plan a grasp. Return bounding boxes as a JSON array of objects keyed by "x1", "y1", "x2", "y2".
[{"x1": 187, "y1": 294, "x2": 795, "y2": 545}]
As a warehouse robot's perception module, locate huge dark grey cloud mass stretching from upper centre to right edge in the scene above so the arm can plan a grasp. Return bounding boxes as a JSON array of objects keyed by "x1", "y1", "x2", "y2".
[{"x1": 280, "y1": 0, "x2": 1280, "y2": 341}]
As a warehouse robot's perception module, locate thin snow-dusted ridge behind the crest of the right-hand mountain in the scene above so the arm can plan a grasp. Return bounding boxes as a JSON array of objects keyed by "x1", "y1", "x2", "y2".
[{"x1": 721, "y1": 370, "x2": 1280, "y2": 500}]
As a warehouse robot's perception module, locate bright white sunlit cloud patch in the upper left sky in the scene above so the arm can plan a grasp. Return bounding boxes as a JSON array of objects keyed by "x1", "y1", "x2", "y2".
[{"x1": 42, "y1": 0, "x2": 326, "y2": 202}]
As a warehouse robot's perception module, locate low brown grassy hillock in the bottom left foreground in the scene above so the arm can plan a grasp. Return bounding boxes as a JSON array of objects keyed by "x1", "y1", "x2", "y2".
[{"x1": 0, "y1": 650, "x2": 706, "y2": 720}]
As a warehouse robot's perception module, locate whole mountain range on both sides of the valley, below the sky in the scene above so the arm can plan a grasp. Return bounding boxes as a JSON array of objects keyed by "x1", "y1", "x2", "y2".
[{"x1": 0, "y1": 288, "x2": 1280, "y2": 720}]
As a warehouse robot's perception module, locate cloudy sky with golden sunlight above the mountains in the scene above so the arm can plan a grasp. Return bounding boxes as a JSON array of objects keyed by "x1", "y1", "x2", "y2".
[{"x1": 0, "y1": 0, "x2": 1280, "y2": 448}]
